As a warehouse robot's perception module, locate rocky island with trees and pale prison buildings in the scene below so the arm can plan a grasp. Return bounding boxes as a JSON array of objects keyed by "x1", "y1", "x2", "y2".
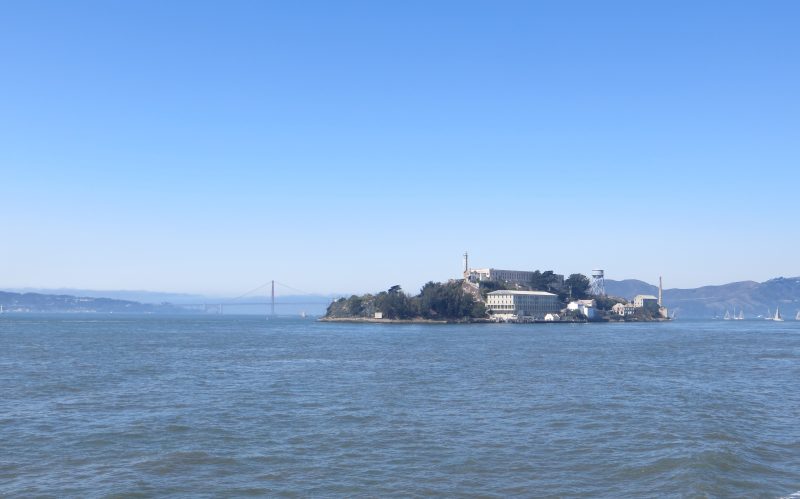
[{"x1": 320, "y1": 269, "x2": 669, "y2": 324}]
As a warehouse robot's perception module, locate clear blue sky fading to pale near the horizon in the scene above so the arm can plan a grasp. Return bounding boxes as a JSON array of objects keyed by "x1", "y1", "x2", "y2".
[{"x1": 0, "y1": 0, "x2": 800, "y2": 295}]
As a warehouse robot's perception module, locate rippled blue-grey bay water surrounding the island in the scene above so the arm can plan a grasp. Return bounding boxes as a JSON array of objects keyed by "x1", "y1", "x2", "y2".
[{"x1": 0, "y1": 314, "x2": 800, "y2": 497}]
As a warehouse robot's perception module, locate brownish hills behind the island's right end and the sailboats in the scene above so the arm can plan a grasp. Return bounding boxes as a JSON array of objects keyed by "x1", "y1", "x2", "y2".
[{"x1": 606, "y1": 277, "x2": 800, "y2": 318}]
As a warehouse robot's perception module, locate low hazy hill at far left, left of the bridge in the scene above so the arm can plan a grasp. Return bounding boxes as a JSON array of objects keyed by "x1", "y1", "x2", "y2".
[{"x1": 0, "y1": 291, "x2": 185, "y2": 314}]
